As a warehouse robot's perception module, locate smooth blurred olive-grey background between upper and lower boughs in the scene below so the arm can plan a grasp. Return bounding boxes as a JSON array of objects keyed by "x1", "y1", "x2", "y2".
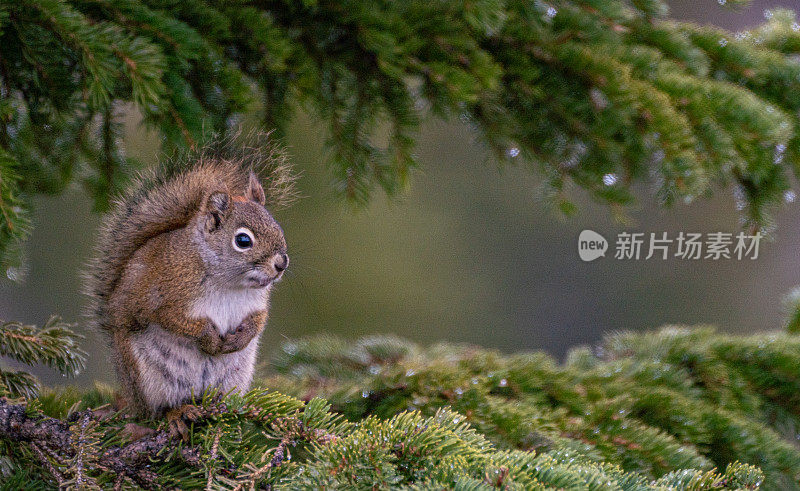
[{"x1": 0, "y1": 0, "x2": 800, "y2": 384}]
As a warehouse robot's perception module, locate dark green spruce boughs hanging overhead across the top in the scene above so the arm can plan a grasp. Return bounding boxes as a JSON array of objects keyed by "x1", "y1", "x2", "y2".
[{"x1": 0, "y1": 0, "x2": 800, "y2": 265}]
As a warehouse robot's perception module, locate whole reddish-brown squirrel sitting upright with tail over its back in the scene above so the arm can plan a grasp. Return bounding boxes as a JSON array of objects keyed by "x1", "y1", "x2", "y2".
[{"x1": 87, "y1": 141, "x2": 292, "y2": 438}]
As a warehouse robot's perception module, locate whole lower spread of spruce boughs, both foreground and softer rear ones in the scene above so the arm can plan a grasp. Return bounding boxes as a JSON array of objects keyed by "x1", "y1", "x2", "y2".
[{"x1": 0, "y1": 327, "x2": 800, "y2": 490}]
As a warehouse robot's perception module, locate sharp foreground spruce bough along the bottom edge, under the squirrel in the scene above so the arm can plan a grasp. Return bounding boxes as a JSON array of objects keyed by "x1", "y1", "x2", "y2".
[{"x1": 0, "y1": 389, "x2": 763, "y2": 490}]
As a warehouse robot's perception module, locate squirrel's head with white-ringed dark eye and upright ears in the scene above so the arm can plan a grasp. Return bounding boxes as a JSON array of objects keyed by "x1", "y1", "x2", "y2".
[{"x1": 197, "y1": 172, "x2": 289, "y2": 288}]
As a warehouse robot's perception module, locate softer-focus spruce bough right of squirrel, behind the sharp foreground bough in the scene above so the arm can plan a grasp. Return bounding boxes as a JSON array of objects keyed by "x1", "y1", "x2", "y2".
[{"x1": 264, "y1": 327, "x2": 800, "y2": 489}]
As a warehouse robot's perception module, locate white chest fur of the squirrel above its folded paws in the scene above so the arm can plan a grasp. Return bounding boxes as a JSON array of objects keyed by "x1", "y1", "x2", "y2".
[{"x1": 189, "y1": 287, "x2": 269, "y2": 335}]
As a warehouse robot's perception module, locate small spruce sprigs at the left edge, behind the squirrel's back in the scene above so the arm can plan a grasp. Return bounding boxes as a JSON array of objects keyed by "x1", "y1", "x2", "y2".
[{"x1": 0, "y1": 316, "x2": 86, "y2": 397}]
